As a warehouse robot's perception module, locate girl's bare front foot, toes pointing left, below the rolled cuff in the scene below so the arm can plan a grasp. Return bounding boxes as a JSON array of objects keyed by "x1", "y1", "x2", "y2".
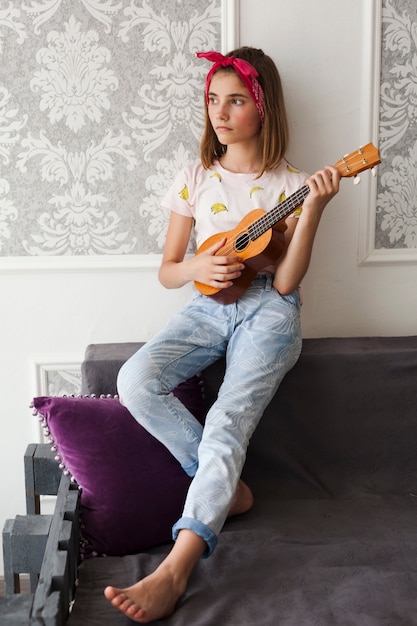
[{"x1": 104, "y1": 563, "x2": 185, "y2": 624}]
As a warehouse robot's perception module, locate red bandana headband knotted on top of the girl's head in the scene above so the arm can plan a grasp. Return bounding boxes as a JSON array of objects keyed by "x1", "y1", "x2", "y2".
[{"x1": 196, "y1": 52, "x2": 265, "y2": 122}]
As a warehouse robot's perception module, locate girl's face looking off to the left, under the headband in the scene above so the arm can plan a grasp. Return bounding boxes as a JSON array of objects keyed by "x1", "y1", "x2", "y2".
[{"x1": 208, "y1": 70, "x2": 261, "y2": 145}]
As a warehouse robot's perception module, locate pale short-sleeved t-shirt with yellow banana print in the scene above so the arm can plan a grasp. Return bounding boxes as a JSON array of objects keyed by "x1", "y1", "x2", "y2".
[{"x1": 162, "y1": 160, "x2": 308, "y2": 247}]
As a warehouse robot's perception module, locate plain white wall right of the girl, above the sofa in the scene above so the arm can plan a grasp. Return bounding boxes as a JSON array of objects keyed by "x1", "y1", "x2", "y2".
[{"x1": 240, "y1": 0, "x2": 417, "y2": 336}]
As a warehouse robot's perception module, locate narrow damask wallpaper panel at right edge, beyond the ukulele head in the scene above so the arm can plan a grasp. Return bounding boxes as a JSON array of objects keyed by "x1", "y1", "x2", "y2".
[{"x1": 375, "y1": 0, "x2": 417, "y2": 249}]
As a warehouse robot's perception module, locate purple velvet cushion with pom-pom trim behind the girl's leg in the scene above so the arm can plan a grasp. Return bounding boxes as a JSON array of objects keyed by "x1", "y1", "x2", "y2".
[{"x1": 33, "y1": 377, "x2": 204, "y2": 557}]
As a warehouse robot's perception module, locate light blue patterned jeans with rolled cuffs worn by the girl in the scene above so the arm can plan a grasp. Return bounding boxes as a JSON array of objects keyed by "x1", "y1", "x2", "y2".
[{"x1": 118, "y1": 276, "x2": 301, "y2": 556}]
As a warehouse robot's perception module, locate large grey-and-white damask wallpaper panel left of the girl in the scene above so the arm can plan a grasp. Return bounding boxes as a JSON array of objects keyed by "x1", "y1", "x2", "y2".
[{"x1": 0, "y1": 0, "x2": 221, "y2": 257}]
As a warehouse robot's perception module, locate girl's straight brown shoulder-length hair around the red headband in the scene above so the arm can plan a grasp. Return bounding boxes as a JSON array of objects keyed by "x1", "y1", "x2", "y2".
[{"x1": 200, "y1": 46, "x2": 289, "y2": 176}]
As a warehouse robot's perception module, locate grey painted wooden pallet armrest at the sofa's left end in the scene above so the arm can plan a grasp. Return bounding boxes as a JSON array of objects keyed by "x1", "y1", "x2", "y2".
[{"x1": 0, "y1": 444, "x2": 80, "y2": 626}]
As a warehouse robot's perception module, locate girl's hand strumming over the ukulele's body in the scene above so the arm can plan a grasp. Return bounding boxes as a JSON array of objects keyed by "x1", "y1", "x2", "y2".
[{"x1": 189, "y1": 237, "x2": 245, "y2": 289}]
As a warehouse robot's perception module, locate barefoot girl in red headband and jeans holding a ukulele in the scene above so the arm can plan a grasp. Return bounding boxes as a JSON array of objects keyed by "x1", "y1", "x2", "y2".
[{"x1": 105, "y1": 47, "x2": 340, "y2": 623}]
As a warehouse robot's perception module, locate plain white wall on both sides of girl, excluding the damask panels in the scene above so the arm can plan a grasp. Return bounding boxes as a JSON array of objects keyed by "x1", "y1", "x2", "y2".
[{"x1": 0, "y1": 0, "x2": 417, "y2": 572}]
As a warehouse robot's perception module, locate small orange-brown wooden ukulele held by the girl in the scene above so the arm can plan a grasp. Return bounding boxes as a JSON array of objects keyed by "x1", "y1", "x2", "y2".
[{"x1": 194, "y1": 143, "x2": 381, "y2": 304}]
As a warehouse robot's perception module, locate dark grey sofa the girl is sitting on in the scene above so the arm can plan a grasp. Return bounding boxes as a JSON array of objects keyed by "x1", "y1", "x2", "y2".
[{"x1": 3, "y1": 337, "x2": 417, "y2": 626}]
